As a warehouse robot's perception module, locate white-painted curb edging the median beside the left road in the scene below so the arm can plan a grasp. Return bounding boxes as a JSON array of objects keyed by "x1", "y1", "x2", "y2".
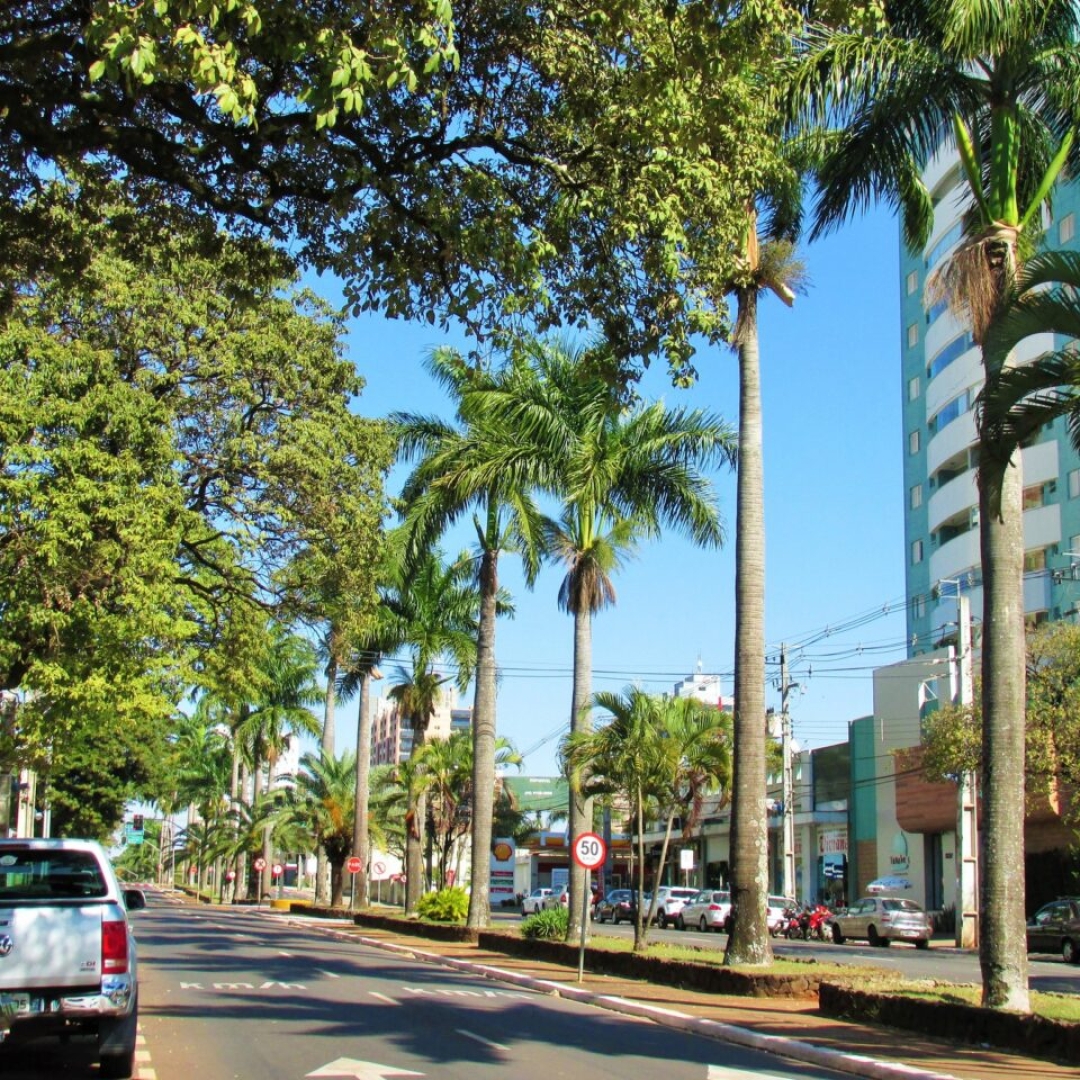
[{"x1": 340, "y1": 934, "x2": 957, "y2": 1080}]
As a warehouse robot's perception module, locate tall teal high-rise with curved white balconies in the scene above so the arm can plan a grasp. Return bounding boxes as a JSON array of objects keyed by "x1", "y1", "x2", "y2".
[{"x1": 901, "y1": 152, "x2": 1080, "y2": 656}]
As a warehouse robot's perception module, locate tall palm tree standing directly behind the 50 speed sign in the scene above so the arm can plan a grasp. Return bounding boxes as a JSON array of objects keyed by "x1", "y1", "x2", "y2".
[{"x1": 491, "y1": 341, "x2": 735, "y2": 937}]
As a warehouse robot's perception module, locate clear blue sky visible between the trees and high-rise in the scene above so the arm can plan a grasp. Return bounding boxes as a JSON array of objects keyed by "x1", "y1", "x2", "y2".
[{"x1": 316, "y1": 203, "x2": 905, "y2": 775}]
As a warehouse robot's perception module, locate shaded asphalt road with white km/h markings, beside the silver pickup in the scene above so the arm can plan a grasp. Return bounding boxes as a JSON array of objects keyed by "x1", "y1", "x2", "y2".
[{"x1": 0, "y1": 894, "x2": 864, "y2": 1080}]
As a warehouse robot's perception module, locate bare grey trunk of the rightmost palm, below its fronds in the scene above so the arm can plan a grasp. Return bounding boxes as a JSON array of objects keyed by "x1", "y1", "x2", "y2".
[{"x1": 978, "y1": 395, "x2": 1030, "y2": 1012}]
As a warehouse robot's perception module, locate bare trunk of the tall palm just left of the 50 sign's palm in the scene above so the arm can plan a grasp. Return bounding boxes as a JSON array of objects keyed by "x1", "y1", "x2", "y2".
[{"x1": 467, "y1": 548, "x2": 499, "y2": 929}]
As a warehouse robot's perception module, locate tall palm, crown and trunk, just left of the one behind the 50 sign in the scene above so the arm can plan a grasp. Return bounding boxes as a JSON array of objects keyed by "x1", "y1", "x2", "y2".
[{"x1": 393, "y1": 349, "x2": 541, "y2": 928}]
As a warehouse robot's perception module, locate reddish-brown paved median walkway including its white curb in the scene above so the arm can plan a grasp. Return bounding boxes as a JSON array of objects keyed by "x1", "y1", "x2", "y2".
[{"x1": 282, "y1": 916, "x2": 1077, "y2": 1080}]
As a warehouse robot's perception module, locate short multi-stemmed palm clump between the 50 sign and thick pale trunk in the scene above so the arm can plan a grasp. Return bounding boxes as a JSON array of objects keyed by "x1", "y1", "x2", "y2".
[{"x1": 562, "y1": 688, "x2": 731, "y2": 951}]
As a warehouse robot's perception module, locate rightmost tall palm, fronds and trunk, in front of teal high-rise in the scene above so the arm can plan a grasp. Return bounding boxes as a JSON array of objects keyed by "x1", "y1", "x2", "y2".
[{"x1": 792, "y1": 0, "x2": 1080, "y2": 1012}]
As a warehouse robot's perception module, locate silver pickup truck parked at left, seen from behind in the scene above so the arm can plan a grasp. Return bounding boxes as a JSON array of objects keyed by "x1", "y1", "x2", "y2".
[{"x1": 0, "y1": 839, "x2": 146, "y2": 1080}]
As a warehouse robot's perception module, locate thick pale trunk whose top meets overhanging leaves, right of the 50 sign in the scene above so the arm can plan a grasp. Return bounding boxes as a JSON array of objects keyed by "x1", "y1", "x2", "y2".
[{"x1": 724, "y1": 288, "x2": 772, "y2": 964}]
